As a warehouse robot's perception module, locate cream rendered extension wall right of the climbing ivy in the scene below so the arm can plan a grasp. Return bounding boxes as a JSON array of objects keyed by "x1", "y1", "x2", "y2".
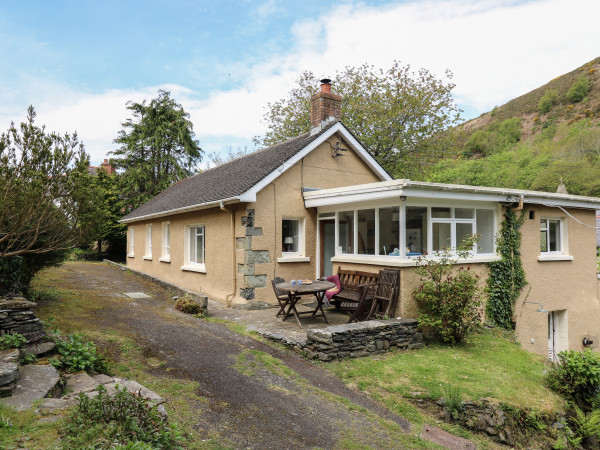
[{"x1": 515, "y1": 206, "x2": 600, "y2": 356}]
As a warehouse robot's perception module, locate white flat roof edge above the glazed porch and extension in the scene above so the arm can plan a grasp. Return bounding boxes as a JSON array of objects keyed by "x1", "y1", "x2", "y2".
[{"x1": 303, "y1": 179, "x2": 600, "y2": 209}]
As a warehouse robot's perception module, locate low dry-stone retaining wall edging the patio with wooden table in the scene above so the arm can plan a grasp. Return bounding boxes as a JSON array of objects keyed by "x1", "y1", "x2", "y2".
[{"x1": 265, "y1": 319, "x2": 423, "y2": 361}]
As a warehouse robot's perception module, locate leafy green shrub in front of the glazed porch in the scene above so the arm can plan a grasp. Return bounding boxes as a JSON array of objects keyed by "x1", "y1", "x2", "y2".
[{"x1": 413, "y1": 238, "x2": 481, "y2": 344}]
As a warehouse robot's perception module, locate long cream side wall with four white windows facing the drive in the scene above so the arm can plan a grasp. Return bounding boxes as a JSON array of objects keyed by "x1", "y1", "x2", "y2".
[{"x1": 127, "y1": 205, "x2": 245, "y2": 301}]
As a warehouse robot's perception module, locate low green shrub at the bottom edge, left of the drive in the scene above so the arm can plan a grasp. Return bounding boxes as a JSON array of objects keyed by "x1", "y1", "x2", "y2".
[{"x1": 61, "y1": 386, "x2": 182, "y2": 450}]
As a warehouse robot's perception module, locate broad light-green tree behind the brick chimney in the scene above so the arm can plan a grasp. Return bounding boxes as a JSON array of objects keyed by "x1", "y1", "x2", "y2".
[{"x1": 255, "y1": 61, "x2": 460, "y2": 176}]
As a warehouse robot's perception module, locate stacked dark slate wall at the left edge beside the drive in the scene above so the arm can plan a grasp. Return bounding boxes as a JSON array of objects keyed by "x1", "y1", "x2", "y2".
[{"x1": 0, "y1": 297, "x2": 46, "y2": 343}]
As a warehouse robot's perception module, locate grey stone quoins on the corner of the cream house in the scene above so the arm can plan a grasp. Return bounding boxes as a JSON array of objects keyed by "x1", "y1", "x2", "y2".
[{"x1": 235, "y1": 209, "x2": 271, "y2": 300}]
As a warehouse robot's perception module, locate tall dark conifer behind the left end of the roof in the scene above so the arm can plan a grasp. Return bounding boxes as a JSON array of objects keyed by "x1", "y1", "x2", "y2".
[{"x1": 112, "y1": 90, "x2": 202, "y2": 208}]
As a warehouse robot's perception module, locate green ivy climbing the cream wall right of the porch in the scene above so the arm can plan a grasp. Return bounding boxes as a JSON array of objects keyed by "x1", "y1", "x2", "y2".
[{"x1": 486, "y1": 207, "x2": 527, "y2": 329}]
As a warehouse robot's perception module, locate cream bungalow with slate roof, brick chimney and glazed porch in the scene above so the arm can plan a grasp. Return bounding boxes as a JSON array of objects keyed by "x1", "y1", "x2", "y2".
[{"x1": 122, "y1": 80, "x2": 600, "y2": 356}]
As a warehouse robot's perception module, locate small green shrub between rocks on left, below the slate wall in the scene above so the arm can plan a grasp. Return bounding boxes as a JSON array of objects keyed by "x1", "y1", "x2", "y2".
[{"x1": 50, "y1": 334, "x2": 108, "y2": 373}]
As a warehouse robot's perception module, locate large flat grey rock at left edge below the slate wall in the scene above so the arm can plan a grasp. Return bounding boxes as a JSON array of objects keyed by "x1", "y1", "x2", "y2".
[{"x1": 0, "y1": 365, "x2": 59, "y2": 411}]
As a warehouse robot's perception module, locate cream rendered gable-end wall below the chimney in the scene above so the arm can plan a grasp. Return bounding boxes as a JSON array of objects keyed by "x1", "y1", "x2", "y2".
[{"x1": 247, "y1": 136, "x2": 381, "y2": 303}]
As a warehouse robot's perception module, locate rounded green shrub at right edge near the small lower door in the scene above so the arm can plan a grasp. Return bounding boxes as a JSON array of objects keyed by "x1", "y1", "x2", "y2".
[{"x1": 546, "y1": 349, "x2": 600, "y2": 406}]
